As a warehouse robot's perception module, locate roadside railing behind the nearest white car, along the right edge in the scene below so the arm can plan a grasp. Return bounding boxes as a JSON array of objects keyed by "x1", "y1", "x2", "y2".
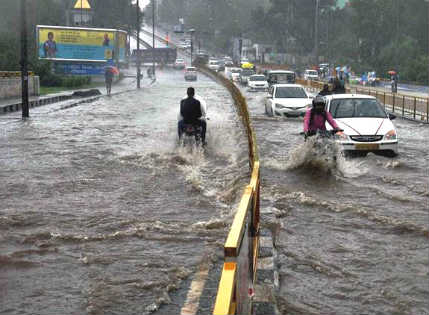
[{"x1": 297, "y1": 79, "x2": 429, "y2": 123}]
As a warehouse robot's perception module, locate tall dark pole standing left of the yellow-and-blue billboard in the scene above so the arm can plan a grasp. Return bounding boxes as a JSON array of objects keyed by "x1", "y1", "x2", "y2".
[{"x1": 21, "y1": 0, "x2": 30, "y2": 118}]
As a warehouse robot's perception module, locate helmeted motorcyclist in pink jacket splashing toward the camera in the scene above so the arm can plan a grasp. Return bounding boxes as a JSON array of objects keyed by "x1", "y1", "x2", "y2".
[{"x1": 304, "y1": 96, "x2": 343, "y2": 137}]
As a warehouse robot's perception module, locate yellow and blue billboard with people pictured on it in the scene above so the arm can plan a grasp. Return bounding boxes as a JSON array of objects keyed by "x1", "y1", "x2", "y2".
[{"x1": 37, "y1": 25, "x2": 115, "y2": 61}]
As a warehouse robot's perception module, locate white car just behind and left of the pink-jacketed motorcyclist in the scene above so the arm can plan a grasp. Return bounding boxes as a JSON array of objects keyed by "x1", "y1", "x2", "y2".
[{"x1": 265, "y1": 84, "x2": 313, "y2": 117}]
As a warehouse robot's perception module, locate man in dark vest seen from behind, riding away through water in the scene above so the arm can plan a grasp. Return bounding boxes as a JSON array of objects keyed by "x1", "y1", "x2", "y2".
[{"x1": 178, "y1": 87, "x2": 207, "y2": 145}]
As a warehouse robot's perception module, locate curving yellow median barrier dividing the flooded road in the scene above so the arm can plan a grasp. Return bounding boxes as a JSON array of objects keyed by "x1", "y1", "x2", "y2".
[{"x1": 199, "y1": 65, "x2": 260, "y2": 315}]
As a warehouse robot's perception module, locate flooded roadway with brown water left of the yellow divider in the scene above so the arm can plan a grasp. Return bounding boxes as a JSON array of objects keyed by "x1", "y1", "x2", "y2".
[{"x1": 0, "y1": 70, "x2": 249, "y2": 315}]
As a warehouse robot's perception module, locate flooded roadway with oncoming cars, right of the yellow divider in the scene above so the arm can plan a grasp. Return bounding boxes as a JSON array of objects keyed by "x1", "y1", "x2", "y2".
[{"x1": 242, "y1": 88, "x2": 429, "y2": 315}]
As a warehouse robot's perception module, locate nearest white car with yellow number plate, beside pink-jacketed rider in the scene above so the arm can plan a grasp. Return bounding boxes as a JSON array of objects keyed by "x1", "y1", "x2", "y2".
[{"x1": 325, "y1": 94, "x2": 398, "y2": 156}]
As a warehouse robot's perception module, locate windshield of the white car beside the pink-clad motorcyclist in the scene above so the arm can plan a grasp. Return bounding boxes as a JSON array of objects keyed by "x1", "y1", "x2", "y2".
[{"x1": 329, "y1": 98, "x2": 387, "y2": 118}]
